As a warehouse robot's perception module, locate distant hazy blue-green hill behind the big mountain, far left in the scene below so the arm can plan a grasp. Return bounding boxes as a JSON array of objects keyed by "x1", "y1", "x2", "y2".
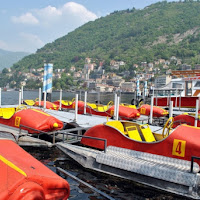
[{"x1": 0, "y1": 49, "x2": 28, "y2": 71}]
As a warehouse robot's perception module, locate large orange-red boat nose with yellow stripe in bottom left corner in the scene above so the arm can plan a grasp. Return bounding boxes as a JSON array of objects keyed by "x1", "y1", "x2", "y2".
[{"x1": 0, "y1": 140, "x2": 70, "y2": 200}]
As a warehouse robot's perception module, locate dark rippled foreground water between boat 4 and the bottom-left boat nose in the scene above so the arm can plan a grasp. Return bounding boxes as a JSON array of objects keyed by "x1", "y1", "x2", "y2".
[{"x1": 25, "y1": 147, "x2": 185, "y2": 200}]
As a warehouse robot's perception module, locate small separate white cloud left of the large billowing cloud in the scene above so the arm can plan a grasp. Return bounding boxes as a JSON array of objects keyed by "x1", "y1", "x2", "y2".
[{"x1": 11, "y1": 12, "x2": 39, "y2": 25}]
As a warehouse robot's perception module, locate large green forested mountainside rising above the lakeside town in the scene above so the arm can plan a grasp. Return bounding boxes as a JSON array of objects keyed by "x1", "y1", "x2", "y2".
[{"x1": 13, "y1": 0, "x2": 200, "y2": 71}]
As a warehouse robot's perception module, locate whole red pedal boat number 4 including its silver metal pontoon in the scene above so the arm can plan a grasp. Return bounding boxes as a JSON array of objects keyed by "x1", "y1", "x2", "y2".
[{"x1": 56, "y1": 119, "x2": 200, "y2": 199}]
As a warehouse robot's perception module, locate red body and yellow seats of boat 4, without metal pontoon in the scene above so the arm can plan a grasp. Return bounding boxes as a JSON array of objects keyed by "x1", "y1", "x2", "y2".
[{"x1": 81, "y1": 118, "x2": 200, "y2": 164}]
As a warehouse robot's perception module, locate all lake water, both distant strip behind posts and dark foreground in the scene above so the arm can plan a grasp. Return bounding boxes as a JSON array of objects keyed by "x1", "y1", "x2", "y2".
[{"x1": 1, "y1": 91, "x2": 183, "y2": 200}]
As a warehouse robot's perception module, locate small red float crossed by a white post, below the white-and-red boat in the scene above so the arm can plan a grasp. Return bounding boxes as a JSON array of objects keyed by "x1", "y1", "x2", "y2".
[{"x1": 138, "y1": 104, "x2": 169, "y2": 117}]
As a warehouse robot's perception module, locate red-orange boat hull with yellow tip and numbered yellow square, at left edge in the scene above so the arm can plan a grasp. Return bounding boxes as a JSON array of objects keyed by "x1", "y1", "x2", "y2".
[{"x1": 0, "y1": 109, "x2": 63, "y2": 133}]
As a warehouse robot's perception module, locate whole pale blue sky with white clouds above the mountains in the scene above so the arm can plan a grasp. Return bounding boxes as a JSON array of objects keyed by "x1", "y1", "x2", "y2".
[{"x1": 0, "y1": 0, "x2": 175, "y2": 53}]
